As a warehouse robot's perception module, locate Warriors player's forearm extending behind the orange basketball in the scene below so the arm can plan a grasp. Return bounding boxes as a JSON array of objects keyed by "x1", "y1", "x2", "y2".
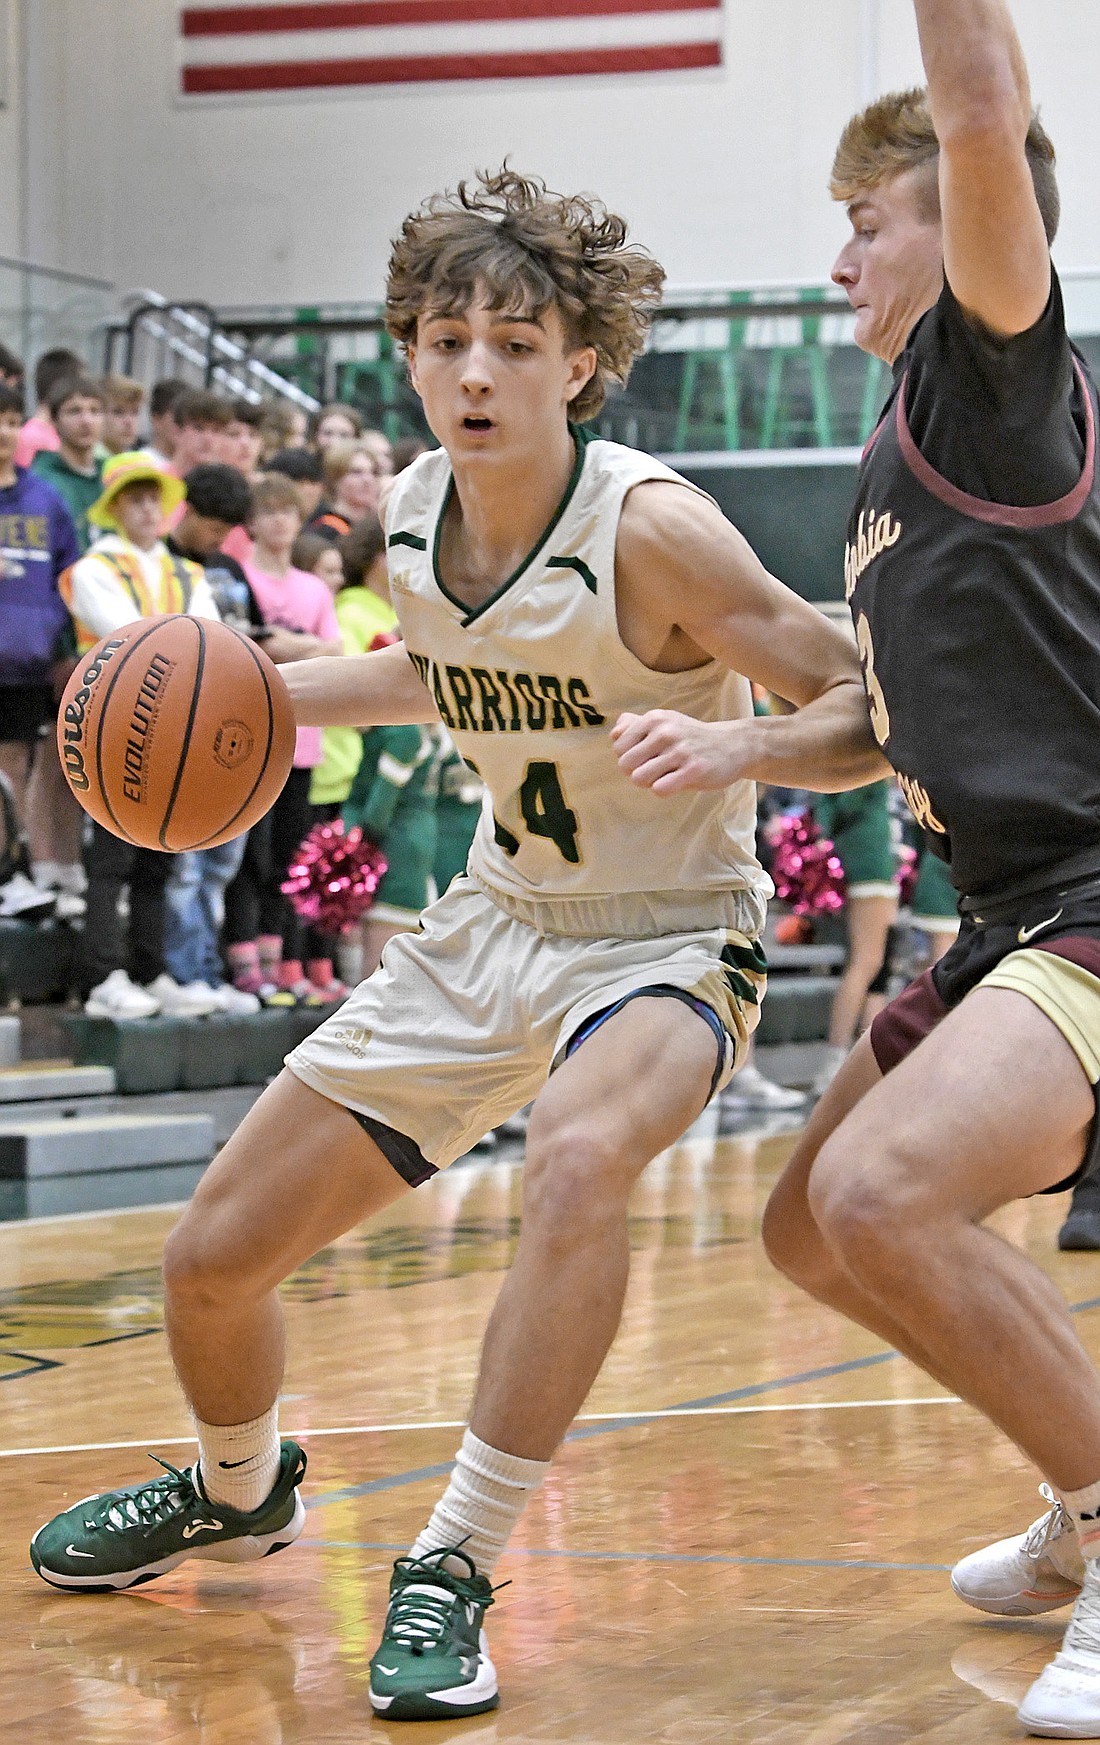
[{"x1": 279, "y1": 642, "x2": 440, "y2": 728}]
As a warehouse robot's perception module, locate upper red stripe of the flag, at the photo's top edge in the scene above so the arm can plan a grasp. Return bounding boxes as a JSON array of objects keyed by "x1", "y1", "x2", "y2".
[{"x1": 182, "y1": 0, "x2": 721, "y2": 37}]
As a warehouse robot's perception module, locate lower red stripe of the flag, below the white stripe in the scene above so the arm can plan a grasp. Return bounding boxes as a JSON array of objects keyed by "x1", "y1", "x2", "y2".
[{"x1": 183, "y1": 42, "x2": 721, "y2": 96}]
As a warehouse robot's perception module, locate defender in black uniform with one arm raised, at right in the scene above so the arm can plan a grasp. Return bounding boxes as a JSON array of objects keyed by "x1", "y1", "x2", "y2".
[{"x1": 765, "y1": 0, "x2": 1100, "y2": 1738}]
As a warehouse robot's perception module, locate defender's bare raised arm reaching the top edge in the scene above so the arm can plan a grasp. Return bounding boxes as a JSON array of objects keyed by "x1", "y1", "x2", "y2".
[{"x1": 913, "y1": 0, "x2": 1051, "y2": 337}]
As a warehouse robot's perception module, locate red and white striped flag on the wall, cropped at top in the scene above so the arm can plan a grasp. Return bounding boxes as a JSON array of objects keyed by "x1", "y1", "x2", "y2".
[{"x1": 180, "y1": 0, "x2": 723, "y2": 98}]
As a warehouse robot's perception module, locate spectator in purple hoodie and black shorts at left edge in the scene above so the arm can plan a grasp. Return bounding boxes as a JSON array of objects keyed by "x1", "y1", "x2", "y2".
[{"x1": 0, "y1": 384, "x2": 80, "y2": 913}]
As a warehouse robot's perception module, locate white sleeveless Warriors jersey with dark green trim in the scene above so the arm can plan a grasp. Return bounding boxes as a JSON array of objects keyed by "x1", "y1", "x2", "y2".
[{"x1": 386, "y1": 440, "x2": 770, "y2": 932}]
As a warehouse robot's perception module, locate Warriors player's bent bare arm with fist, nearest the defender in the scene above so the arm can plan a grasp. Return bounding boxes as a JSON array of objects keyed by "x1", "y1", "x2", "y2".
[{"x1": 611, "y1": 483, "x2": 889, "y2": 794}]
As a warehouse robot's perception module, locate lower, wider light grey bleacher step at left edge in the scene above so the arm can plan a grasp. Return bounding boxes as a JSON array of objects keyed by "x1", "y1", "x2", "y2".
[{"x1": 0, "y1": 1113, "x2": 215, "y2": 1180}]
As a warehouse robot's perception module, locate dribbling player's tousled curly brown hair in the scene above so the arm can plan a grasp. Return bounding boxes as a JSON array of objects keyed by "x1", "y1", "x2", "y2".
[{"x1": 386, "y1": 164, "x2": 665, "y2": 424}]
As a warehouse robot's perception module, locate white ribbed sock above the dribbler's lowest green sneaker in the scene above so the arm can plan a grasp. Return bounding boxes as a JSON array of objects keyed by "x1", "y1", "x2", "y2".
[{"x1": 409, "y1": 1429, "x2": 550, "y2": 1576}]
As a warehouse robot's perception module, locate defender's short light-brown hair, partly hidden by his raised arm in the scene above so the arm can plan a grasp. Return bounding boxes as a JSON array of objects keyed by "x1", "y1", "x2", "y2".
[{"x1": 829, "y1": 86, "x2": 1062, "y2": 243}]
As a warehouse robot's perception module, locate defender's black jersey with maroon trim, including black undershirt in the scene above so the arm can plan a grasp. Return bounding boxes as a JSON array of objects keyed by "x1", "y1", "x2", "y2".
[{"x1": 845, "y1": 281, "x2": 1100, "y2": 897}]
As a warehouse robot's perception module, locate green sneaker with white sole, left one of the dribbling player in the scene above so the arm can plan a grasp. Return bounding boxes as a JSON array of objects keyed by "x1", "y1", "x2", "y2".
[{"x1": 31, "y1": 1441, "x2": 306, "y2": 1593}]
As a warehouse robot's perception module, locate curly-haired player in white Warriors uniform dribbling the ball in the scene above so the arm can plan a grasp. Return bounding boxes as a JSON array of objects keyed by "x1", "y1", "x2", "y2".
[{"x1": 31, "y1": 171, "x2": 883, "y2": 1719}]
